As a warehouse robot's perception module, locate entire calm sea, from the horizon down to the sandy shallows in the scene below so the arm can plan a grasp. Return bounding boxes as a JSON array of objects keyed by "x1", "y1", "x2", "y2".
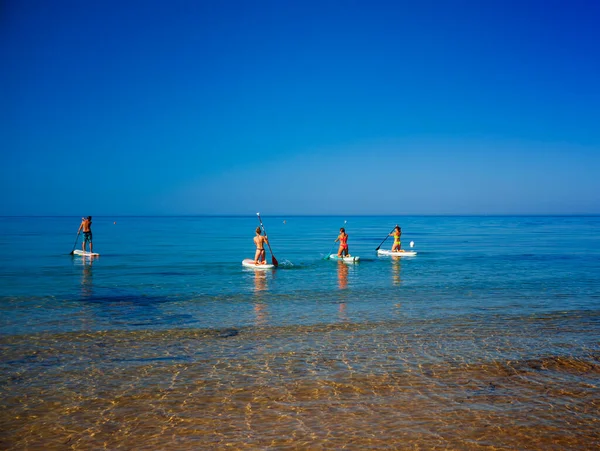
[{"x1": 0, "y1": 217, "x2": 600, "y2": 450}]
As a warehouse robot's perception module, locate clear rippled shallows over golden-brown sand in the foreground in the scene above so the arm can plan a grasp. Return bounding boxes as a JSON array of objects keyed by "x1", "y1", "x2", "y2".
[{"x1": 0, "y1": 312, "x2": 600, "y2": 450}]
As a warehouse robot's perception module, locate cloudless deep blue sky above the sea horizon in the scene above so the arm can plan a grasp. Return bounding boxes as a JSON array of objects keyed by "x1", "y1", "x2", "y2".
[{"x1": 0, "y1": 0, "x2": 600, "y2": 216}]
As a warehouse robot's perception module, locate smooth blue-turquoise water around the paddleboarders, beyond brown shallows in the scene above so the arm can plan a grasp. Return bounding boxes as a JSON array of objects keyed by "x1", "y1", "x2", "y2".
[{"x1": 0, "y1": 217, "x2": 600, "y2": 334}]
